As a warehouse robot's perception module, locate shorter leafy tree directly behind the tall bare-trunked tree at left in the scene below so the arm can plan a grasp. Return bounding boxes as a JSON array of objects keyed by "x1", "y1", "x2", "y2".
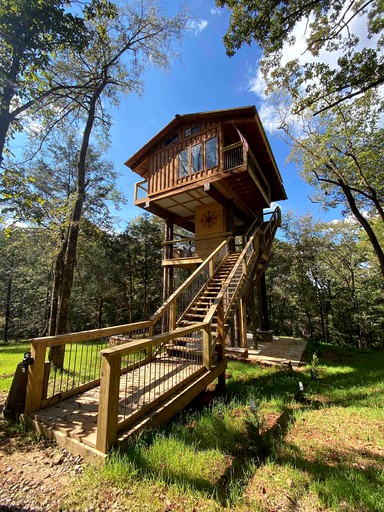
[{"x1": 20, "y1": 125, "x2": 122, "y2": 340}]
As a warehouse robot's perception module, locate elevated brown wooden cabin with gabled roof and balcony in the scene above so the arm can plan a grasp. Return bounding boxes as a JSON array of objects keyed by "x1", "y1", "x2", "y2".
[{"x1": 125, "y1": 106, "x2": 287, "y2": 294}]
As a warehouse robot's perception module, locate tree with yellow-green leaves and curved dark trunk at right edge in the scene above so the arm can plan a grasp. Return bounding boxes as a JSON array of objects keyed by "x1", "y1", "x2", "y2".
[{"x1": 282, "y1": 91, "x2": 384, "y2": 277}]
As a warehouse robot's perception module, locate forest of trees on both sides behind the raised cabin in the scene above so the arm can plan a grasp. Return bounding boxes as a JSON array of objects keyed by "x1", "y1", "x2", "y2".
[{"x1": 0, "y1": 0, "x2": 384, "y2": 349}]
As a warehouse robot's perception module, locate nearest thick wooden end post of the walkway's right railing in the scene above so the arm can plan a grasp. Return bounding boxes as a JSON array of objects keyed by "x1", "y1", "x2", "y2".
[{"x1": 96, "y1": 352, "x2": 121, "y2": 453}]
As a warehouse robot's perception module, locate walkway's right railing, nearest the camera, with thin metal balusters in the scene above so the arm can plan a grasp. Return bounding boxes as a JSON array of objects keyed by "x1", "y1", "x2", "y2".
[{"x1": 96, "y1": 322, "x2": 211, "y2": 453}]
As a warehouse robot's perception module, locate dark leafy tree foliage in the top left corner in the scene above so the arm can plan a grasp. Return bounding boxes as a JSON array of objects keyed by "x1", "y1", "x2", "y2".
[{"x1": 0, "y1": 0, "x2": 87, "y2": 167}]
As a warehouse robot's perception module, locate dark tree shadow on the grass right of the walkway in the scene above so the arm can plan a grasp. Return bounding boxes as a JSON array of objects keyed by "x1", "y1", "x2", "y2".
[{"x1": 109, "y1": 347, "x2": 384, "y2": 510}]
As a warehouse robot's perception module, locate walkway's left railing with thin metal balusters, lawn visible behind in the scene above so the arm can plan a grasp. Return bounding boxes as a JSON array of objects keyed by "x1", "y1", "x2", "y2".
[{"x1": 25, "y1": 322, "x2": 151, "y2": 413}]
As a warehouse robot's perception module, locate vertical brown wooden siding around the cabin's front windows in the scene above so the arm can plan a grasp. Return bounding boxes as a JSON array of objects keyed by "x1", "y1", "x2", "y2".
[{"x1": 148, "y1": 122, "x2": 221, "y2": 197}]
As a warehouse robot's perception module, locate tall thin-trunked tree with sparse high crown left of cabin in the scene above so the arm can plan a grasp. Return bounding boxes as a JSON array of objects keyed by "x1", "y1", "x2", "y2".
[{"x1": 26, "y1": 0, "x2": 188, "y2": 352}]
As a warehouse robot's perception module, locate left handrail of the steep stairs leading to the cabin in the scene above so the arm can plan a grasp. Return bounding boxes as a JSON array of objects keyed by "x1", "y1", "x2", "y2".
[{"x1": 150, "y1": 235, "x2": 234, "y2": 330}]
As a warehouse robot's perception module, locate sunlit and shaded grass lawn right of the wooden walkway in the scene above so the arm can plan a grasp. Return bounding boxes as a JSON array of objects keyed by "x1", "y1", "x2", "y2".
[{"x1": 0, "y1": 338, "x2": 384, "y2": 512}]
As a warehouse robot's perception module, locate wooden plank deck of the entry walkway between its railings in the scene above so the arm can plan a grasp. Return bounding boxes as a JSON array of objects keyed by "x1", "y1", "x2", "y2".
[{"x1": 26, "y1": 354, "x2": 202, "y2": 458}]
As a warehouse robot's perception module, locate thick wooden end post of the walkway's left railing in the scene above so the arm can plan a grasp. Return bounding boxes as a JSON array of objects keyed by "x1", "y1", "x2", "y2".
[{"x1": 25, "y1": 341, "x2": 47, "y2": 414}]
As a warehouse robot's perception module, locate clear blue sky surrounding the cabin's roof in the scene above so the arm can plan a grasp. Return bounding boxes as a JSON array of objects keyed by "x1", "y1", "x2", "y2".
[{"x1": 109, "y1": 0, "x2": 337, "y2": 227}]
